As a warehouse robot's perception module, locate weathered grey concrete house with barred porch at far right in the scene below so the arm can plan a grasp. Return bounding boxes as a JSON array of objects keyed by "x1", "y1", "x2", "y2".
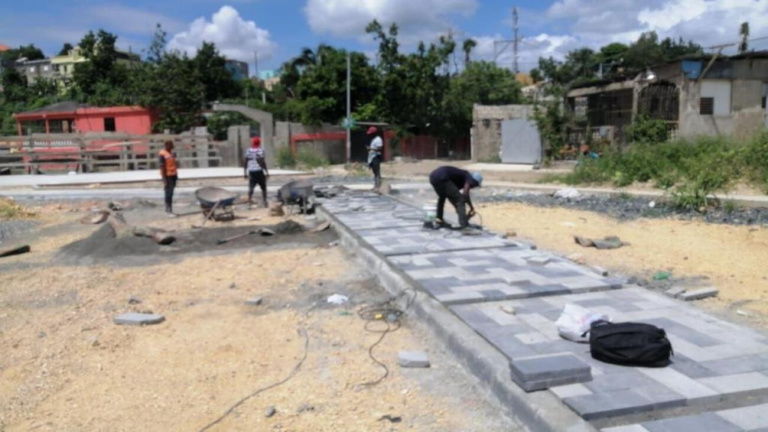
[{"x1": 565, "y1": 51, "x2": 768, "y2": 143}]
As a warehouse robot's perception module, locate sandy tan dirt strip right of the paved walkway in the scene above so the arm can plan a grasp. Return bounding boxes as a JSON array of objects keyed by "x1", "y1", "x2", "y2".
[{"x1": 479, "y1": 203, "x2": 768, "y2": 327}]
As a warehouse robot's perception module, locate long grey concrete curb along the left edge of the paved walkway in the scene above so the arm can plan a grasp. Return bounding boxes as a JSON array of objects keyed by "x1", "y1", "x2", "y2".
[{"x1": 317, "y1": 206, "x2": 597, "y2": 432}]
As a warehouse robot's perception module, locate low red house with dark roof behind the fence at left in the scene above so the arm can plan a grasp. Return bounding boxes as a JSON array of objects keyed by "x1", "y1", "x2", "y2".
[{"x1": 13, "y1": 102, "x2": 155, "y2": 135}]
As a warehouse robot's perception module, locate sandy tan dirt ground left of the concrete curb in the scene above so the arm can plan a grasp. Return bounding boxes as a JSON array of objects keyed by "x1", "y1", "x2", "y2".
[{"x1": 0, "y1": 203, "x2": 519, "y2": 432}]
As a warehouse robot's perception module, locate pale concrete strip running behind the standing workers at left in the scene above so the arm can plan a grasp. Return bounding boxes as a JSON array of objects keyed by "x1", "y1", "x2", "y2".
[{"x1": 0, "y1": 168, "x2": 305, "y2": 188}]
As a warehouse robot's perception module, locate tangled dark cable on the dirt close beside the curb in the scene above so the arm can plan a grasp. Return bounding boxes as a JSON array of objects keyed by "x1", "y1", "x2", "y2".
[{"x1": 357, "y1": 288, "x2": 417, "y2": 387}]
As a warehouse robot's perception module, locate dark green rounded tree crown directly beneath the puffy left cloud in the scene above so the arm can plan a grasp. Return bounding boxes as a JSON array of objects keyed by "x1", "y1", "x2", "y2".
[{"x1": 192, "y1": 42, "x2": 238, "y2": 102}]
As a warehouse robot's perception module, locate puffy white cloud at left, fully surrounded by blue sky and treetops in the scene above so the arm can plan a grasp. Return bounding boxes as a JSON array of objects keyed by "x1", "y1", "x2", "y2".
[{"x1": 168, "y1": 6, "x2": 277, "y2": 63}]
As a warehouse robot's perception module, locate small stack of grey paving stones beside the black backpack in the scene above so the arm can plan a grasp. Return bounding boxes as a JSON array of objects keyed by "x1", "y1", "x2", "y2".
[{"x1": 509, "y1": 354, "x2": 592, "y2": 391}]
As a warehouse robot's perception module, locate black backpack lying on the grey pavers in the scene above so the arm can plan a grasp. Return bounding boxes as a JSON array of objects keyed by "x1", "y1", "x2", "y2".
[{"x1": 589, "y1": 321, "x2": 674, "y2": 367}]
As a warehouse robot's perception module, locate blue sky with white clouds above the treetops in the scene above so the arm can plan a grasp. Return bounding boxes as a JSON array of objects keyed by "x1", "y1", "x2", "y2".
[{"x1": 0, "y1": 0, "x2": 768, "y2": 73}]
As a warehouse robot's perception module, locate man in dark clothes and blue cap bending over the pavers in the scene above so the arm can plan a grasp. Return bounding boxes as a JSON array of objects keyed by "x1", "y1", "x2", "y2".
[{"x1": 429, "y1": 166, "x2": 483, "y2": 229}]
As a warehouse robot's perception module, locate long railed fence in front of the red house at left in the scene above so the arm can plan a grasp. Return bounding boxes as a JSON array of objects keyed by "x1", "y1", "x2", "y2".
[{"x1": 0, "y1": 133, "x2": 221, "y2": 174}]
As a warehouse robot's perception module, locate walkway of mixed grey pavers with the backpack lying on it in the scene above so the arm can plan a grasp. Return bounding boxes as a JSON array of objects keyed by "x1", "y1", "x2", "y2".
[{"x1": 323, "y1": 193, "x2": 768, "y2": 432}]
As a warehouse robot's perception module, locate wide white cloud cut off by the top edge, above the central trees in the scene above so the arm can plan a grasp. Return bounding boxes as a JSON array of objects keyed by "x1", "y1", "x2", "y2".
[{"x1": 304, "y1": 0, "x2": 478, "y2": 43}]
